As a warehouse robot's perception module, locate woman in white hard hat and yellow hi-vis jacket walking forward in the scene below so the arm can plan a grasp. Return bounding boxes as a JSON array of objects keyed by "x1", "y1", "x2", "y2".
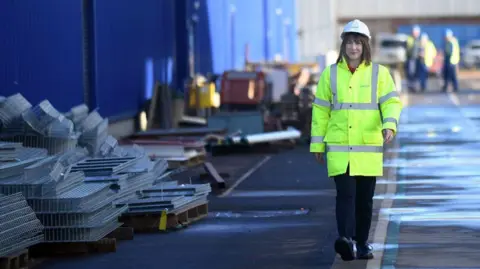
[{"x1": 310, "y1": 20, "x2": 402, "y2": 260}]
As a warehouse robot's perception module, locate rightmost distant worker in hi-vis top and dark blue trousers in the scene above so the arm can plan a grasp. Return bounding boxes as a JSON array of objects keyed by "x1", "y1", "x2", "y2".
[{"x1": 443, "y1": 29, "x2": 460, "y2": 92}]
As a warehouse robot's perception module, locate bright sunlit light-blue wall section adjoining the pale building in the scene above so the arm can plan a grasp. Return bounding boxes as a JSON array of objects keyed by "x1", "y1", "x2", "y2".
[{"x1": 187, "y1": 0, "x2": 297, "y2": 73}]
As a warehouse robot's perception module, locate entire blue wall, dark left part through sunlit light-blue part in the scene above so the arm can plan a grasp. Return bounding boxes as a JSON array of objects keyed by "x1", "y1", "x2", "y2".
[{"x1": 0, "y1": 0, "x2": 297, "y2": 116}]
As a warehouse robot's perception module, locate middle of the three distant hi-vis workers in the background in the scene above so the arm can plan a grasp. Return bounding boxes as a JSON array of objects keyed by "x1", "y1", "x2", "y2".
[{"x1": 418, "y1": 33, "x2": 437, "y2": 92}]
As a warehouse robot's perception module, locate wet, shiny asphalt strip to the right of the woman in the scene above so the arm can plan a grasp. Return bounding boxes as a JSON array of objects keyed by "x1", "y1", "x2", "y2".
[{"x1": 333, "y1": 85, "x2": 480, "y2": 269}]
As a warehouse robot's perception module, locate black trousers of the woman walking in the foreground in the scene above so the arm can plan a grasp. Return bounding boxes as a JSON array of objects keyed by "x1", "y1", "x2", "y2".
[{"x1": 334, "y1": 165, "x2": 377, "y2": 244}]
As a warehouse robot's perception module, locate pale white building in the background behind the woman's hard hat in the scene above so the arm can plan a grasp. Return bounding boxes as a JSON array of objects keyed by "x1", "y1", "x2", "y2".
[{"x1": 296, "y1": 0, "x2": 480, "y2": 60}]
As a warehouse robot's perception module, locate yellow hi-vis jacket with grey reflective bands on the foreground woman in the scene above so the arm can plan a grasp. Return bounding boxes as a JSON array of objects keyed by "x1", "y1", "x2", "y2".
[{"x1": 310, "y1": 60, "x2": 402, "y2": 177}]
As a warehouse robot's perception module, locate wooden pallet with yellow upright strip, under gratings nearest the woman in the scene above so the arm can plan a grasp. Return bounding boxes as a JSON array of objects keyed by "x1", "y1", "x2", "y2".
[{"x1": 120, "y1": 202, "x2": 208, "y2": 233}]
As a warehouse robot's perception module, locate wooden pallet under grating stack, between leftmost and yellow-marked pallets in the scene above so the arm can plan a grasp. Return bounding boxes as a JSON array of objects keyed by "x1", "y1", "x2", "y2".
[{"x1": 30, "y1": 238, "x2": 117, "y2": 257}]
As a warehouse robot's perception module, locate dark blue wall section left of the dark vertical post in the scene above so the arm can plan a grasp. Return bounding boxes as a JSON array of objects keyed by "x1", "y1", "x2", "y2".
[{"x1": 0, "y1": 0, "x2": 83, "y2": 111}]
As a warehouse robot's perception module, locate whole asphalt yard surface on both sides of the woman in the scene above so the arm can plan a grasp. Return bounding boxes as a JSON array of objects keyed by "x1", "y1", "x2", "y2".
[{"x1": 39, "y1": 87, "x2": 480, "y2": 269}]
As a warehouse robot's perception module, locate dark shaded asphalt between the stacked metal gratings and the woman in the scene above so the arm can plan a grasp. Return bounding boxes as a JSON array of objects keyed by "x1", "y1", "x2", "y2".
[{"x1": 37, "y1": 146, "x2": 336, "y2": 269}]
